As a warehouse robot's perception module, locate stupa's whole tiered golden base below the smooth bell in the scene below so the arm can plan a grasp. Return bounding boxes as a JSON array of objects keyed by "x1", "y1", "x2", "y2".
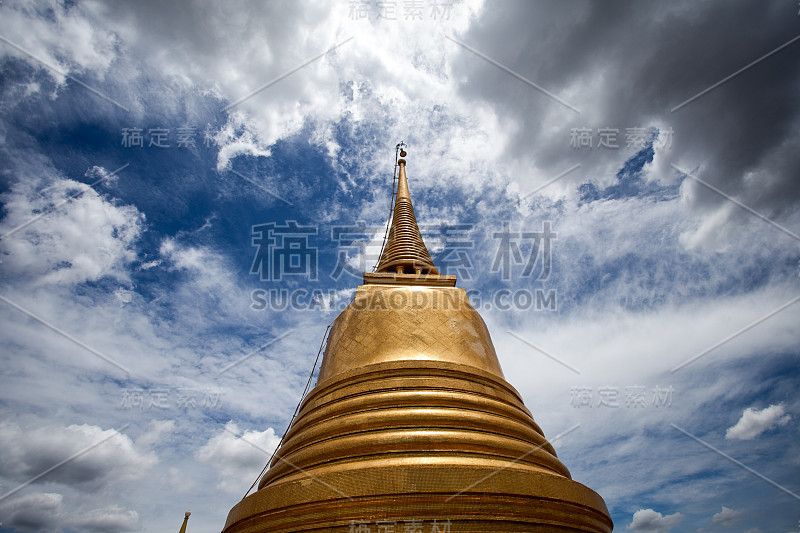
[{"x1": 224, "y1": 361, "x2": 612, "y2": 533}]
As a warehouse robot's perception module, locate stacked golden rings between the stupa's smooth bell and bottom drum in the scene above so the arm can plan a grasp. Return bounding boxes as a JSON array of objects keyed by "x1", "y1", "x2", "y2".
[{"x1": 259, "y1": 361, "x2": 569, "y2": 488}]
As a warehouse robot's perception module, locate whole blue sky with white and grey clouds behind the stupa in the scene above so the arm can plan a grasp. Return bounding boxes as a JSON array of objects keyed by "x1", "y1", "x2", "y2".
[{"x1": 0, "y1": 0, "x2": 800, "y2": 533}]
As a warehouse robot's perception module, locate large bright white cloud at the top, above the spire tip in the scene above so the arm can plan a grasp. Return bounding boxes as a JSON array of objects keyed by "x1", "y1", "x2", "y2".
[{"x1": 81, "y1": 1, "x2": 508, "y2": 184}]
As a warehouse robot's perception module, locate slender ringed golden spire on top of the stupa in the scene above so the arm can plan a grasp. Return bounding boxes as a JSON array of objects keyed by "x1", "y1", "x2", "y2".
[{"x1": 376, "y1": 150, "x2": 439, "y2": 275}]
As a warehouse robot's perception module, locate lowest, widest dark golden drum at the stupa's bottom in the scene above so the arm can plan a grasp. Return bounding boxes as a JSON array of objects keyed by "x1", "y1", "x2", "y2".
[{"x1": 230, "y1": 465, "x2": 612, "y2": 533}]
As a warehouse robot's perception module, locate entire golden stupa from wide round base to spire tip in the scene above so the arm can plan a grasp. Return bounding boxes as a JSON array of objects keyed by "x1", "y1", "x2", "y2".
[{"x1": 223, "y1": 148, "x2": 613, "y2": 533}]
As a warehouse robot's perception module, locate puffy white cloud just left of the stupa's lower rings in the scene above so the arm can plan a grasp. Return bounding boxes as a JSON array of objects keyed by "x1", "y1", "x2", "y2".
[{"x1": 195, "y1": 421, "x2": 280, "y2": 494}]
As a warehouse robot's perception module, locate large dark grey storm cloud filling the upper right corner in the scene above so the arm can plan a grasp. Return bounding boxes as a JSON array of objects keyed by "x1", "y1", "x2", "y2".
[{"x1": 454, "y1": 1, "x2": 800, "y2": 216}]
